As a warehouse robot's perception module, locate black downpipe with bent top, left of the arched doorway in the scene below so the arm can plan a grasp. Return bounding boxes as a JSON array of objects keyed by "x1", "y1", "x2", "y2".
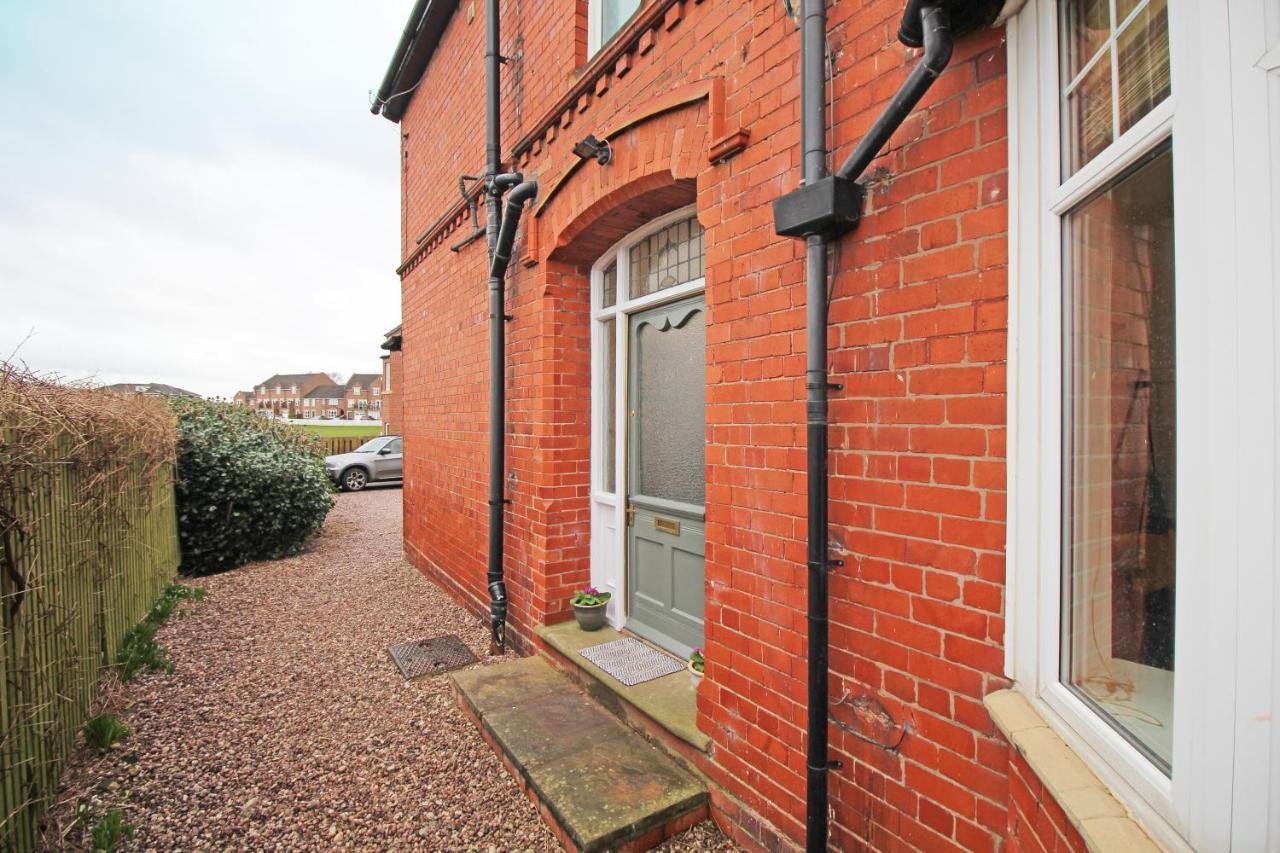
[{"x1": 486, "y1": 174, "x2": 538, "y2": 654}]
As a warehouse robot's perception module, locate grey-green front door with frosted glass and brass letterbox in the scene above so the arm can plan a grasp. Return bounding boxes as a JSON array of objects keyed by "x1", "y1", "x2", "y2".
[{"x1": 627, "y1": 296, "x2": 707, "y2": 656}]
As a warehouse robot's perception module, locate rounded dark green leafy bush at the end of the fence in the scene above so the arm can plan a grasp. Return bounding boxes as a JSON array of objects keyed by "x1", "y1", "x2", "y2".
[{"x1": 173, "y1": 397, "x2": 333, "y2": 575}]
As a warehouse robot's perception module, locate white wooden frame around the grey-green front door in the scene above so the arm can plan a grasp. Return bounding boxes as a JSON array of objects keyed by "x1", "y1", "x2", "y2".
[{"x1": 590, "y1": 205, "x2": 707, "y2": 629}]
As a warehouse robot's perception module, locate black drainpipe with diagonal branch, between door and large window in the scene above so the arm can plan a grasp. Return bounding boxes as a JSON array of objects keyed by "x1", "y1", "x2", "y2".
[{"x1": 773, "y1": 0, "x2": 977, "y2": 853}]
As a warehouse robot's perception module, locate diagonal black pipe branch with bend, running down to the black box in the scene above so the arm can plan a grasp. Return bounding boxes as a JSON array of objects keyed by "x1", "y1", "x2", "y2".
[{"x1": 836, "y1": 0, "x2": 955, "y2": 181}]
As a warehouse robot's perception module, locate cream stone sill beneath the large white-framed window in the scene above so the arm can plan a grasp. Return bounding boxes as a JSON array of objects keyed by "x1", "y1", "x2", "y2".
[{"x1": 983, "y1": 690, "x2": 1160, "y2": 853}]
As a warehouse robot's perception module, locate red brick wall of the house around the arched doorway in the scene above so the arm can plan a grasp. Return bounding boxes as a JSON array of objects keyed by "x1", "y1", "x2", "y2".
[{"x1": 396, "y1": 0, "x2": 1039, "y2": 850}]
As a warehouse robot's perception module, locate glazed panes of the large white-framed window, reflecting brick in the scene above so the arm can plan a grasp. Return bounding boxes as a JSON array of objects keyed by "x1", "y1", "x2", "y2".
[{"x1": 1055, "y1": 0, "x2": 1176, "y2": 758}]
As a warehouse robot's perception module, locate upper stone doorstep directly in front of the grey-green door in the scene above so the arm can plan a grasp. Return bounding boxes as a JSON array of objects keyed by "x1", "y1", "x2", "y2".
[{"x1": 536, "y1": 621, "x2": 712, "y2": 768}]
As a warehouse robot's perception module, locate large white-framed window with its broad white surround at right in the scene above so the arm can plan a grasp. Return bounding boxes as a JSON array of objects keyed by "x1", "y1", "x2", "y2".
[{"x1": 1006, "y1": 0, "x2": 1280, "y2": 849}]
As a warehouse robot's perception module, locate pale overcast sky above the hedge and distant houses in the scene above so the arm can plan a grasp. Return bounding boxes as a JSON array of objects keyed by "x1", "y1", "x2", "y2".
[{"x1": 0, "y1": 0, "x2": 412, "y2": 396}]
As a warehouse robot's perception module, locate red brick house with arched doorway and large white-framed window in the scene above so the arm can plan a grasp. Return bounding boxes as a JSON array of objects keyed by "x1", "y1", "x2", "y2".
[{"x1": 375, "y1": 0, "x2": 1280, "y2": 850}]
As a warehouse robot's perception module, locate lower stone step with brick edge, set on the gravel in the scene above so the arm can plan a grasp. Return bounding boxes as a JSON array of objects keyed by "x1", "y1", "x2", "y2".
[{"x1": 453, "y1": 657, "x2": 708, "y2": 850}]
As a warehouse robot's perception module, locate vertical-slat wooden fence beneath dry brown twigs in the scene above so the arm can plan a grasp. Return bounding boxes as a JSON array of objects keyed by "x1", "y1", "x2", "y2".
[{"x1": 0, "y1": 430, "x2": 180, "y2": 850}]
